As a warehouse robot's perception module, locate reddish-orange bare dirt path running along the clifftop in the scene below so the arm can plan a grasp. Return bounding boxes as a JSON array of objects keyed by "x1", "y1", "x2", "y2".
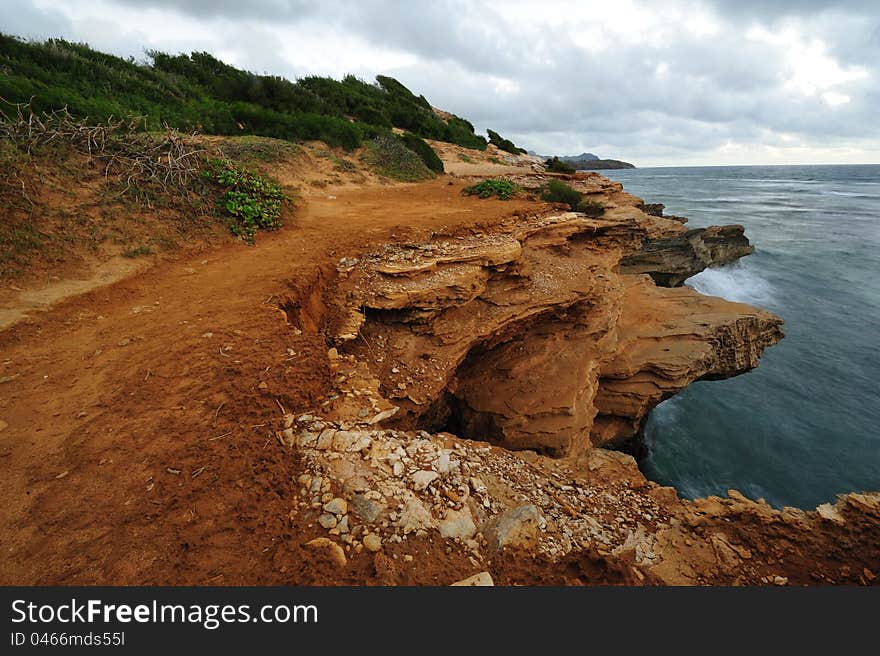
[{"x1": 0, "y1": 179, "x2": 535, "y2": 584}]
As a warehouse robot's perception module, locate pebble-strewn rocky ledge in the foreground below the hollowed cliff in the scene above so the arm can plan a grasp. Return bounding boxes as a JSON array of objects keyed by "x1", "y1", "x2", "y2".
[{"x1": 276, "y1": 415, "x2": 880, "y2": 585}]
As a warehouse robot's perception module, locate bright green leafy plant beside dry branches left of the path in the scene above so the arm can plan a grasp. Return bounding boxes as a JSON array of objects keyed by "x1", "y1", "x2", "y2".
[{"x1": 204, "y1": 158, "x2": 285, "y2": 243}]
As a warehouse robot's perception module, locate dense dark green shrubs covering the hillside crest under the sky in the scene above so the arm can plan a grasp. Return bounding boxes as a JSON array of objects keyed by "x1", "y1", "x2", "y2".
[{"x1": 0, "y1": 34, "x2": 496, "y2": 150}]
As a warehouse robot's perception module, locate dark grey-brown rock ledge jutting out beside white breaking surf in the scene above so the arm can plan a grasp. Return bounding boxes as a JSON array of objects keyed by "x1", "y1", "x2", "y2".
[{"x1": 620, "y1": 225, "x2": 755, "y2": 287}]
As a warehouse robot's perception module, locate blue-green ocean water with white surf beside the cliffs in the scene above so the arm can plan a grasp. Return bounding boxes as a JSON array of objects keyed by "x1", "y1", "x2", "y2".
[{"x1": 602, "y1": 165, "x2": 880, "y2": 508}]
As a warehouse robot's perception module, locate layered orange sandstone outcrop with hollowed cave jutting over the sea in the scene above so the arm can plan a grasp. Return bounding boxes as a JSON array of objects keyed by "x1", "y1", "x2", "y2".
[{"x1": 335, "y1": 192, "x2": 782, "y2": 456}]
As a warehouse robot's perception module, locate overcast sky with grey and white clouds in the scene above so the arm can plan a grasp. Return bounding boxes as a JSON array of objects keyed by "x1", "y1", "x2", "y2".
[{"x1": 0, "y1": 0, "x2": 880, "y2": 166}]
